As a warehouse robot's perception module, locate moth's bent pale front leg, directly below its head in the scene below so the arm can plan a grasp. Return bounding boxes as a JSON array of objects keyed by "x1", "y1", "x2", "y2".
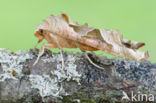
[{"x1": 33, "y1": 43, "x2": 56, "y2": 66}]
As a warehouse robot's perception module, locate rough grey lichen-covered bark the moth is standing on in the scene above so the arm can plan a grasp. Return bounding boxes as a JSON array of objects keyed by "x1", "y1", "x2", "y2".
[{"x1": 0, "y1": 50, "x2": 156, "y2": 103}]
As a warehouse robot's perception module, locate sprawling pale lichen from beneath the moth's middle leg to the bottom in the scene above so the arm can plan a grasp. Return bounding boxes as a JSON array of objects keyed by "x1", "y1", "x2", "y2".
[{"x1": 29, "y1": 54, "x2": 81, "y2": 100}]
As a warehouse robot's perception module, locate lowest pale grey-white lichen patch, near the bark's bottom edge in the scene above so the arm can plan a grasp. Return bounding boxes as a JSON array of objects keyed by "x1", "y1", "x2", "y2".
[{"x1": 29, "y1": 75, "x2": 60, "y2": 97}]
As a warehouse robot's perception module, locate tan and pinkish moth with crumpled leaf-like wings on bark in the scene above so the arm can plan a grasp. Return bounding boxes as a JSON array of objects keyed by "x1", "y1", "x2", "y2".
[{"x1": 34, "y1": 13, "x2": 149, "y2": 68}]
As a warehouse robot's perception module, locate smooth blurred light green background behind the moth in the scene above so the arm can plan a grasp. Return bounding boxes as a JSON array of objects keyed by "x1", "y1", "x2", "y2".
[{"x1": 0, "y1": 0, "x2": 156, "y2": 62}]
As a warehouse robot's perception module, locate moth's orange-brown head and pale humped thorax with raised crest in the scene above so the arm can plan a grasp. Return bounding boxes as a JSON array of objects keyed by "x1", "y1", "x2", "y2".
[{"x1": 34, "y1": 13, "x2": 70, "y2": 39}]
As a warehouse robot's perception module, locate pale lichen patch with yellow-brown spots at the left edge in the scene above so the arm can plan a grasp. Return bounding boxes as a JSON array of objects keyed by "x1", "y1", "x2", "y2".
[{"x1": 0, "y1": 48, "x2": 34, "y2": 81}]
